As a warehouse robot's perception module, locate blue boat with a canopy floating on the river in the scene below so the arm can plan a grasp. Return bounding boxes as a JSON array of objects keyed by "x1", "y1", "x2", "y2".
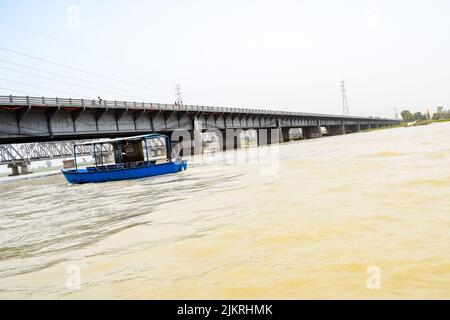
[{"x1": 61, "y1": 134, "x2": 187, "y2": 184}]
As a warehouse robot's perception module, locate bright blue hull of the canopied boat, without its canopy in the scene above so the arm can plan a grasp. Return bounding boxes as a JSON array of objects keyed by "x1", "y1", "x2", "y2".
[{"x1": 61, "y1": 161, "x2": 187, "y2": 184}]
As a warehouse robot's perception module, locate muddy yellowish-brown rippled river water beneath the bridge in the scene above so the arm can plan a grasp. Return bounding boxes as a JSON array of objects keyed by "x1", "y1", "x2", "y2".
[{"x1": 0, "y1": 123, "x2": 450, "y2": 299}]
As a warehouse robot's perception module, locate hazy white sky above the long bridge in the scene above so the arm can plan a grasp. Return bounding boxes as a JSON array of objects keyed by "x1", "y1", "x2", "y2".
[{"x1": 0, "y1": 0, "x2": 450, "y2": 117}]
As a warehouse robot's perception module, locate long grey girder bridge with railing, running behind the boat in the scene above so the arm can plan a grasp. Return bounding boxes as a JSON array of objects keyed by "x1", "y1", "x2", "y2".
[{"x1": 0, "y1": 95, "x2": 399, "y2": 148}]
